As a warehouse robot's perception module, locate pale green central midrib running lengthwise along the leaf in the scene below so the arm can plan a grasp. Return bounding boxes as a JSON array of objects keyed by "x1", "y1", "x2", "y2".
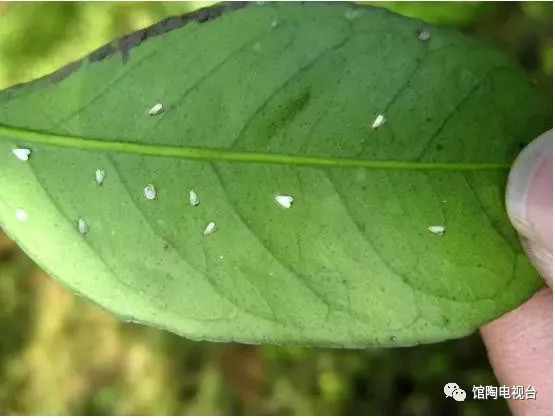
[{"x1": 0, "y1": 125, "x2": 510, "y2": 171}]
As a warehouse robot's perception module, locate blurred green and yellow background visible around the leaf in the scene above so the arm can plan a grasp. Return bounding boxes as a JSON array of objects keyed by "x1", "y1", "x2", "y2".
[{"x1": 0, "y1": 2, "x2": 553, "y2": 415}]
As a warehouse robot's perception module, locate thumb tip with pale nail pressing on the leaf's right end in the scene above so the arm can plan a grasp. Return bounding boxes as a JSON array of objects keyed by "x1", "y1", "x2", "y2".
[{"x1": 506, "y1": 130, "x2": 553, "y2": 286}]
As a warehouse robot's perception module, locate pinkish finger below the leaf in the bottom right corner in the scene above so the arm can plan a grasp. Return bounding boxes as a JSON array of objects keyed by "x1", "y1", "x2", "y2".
[{"x1": 480, "y1": 288, "x2": 553, "y2": 415}]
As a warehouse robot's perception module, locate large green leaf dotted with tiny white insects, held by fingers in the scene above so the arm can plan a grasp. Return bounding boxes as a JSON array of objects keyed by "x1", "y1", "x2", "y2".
[{"x1": 0, "y1": 3, "x2": 551, "y2": 347}]
